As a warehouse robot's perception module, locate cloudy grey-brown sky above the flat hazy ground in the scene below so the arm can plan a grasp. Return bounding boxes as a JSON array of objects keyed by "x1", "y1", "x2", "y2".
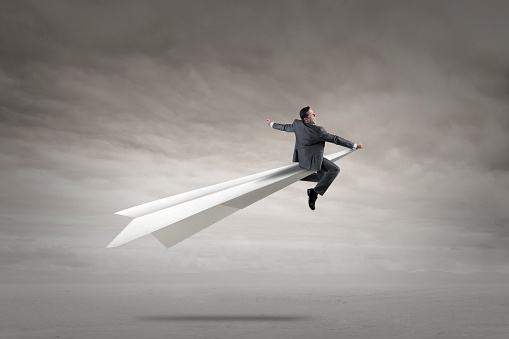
[{"x1": 0, "y1": 0, "x2": 509, "y2": 275}]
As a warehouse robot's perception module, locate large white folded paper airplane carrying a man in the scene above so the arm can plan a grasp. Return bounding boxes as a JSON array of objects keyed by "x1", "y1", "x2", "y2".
[{"x1": 108, "y1": 149, "x2": 354, "y2": 248}]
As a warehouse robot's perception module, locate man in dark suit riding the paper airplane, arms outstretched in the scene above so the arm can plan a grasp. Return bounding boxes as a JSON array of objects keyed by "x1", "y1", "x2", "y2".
[{"x1": 267, "y1": 106, "x2": 362, "y2": 210}]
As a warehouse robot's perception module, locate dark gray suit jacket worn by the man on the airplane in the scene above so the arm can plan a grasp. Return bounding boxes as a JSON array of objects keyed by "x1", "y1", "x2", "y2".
[{"x1": 272, "y1": 119, "x2": 354, "y2": 171}]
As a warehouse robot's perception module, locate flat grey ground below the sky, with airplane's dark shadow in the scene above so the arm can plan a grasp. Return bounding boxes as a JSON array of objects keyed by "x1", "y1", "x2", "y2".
[{"x1": 0, "y1": 273, "x2": 509, "y2": 339}]
